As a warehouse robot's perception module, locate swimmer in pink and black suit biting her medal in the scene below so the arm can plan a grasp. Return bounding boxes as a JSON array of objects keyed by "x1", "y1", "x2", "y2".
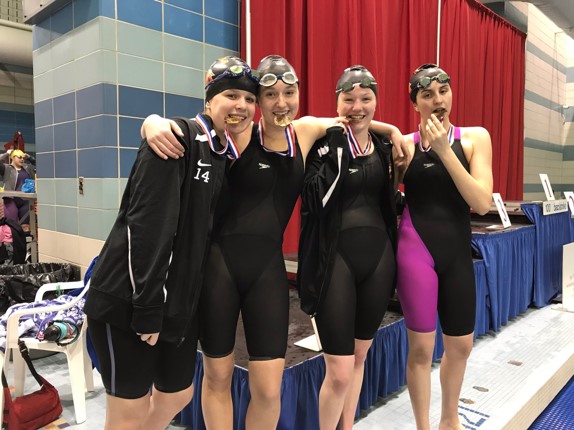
[{"x1": 397, "y1": 64, "x2": 493, "y2": 430}]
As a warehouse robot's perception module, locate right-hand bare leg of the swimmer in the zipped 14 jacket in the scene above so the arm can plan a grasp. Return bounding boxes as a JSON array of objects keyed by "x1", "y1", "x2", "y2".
[{"x1": 143, "y1": 385, "x2": 193, "y2": 430}]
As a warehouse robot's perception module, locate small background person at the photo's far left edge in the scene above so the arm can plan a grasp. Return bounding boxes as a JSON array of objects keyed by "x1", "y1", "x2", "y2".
[{"x1": 0, "y1": 149, "x2": 36, "y2": 225}]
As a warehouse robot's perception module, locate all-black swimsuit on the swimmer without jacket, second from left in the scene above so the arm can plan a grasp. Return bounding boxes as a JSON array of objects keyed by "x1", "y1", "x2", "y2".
[{"x1": 200, "y1": 126, "x2": 304, "y2": 360}]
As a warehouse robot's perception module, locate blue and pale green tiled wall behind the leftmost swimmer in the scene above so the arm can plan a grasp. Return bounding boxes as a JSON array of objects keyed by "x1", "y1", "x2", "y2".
[{"x1": 33, "y1": 0, "x2": 239, "y2": 268}]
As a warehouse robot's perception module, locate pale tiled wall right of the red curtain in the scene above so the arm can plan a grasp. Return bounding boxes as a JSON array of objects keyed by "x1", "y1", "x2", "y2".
[{"x1": 512, "y1": 2, "x2": 574, "y2": 200}]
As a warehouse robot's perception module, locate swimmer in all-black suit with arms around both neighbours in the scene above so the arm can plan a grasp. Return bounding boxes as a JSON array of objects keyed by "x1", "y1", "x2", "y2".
[{"x1": 142, "y1": 55, "x2": 408, "y2": 429}]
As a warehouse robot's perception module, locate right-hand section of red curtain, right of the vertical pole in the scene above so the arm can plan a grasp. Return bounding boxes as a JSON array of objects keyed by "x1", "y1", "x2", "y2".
[{"x1": 440, "y1": 0, "x2": 526, "y2": 200}]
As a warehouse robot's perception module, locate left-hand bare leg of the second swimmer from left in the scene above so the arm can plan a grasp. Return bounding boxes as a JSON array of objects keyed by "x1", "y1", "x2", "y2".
[{"x1": 205, "y1": 354, "x2": 235, "y2": 429}]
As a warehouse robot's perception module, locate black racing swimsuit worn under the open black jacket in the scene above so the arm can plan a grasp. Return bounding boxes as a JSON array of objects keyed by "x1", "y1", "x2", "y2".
[{"x1": 315, "y1": 152, "x2": 395, "y2": 355}]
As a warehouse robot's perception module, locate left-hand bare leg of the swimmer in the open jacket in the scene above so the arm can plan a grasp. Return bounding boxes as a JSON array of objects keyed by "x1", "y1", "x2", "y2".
[{"x1": 319, "y1": 354, "x2": 355, "y2": 430}]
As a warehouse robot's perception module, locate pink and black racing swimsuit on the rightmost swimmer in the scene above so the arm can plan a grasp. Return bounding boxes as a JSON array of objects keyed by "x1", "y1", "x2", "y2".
[{"x1": 397, "y1": 127, "x2": 476, "y2": 336}]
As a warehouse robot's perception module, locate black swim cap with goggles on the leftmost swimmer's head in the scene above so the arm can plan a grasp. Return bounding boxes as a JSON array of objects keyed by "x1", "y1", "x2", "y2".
[{"x1": 205, "y1": 55, "x2": 259, "y2": 102}]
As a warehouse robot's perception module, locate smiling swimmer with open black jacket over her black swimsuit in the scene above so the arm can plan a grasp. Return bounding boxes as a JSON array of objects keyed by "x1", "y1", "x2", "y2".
[{"x1": 297, "y1": 66, "x2": 397, "y2": 430}]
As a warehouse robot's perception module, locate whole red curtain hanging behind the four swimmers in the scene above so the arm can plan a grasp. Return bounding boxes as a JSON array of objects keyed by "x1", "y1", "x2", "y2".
[{"x1": 241, "y1": 0, "x2": 524, "y2": 253}]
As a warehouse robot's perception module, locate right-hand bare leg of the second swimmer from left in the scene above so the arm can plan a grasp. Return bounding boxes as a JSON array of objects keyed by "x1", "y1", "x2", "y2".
[{"x1": 245, "y1": 358, "x2": 285, "y2": 430}]
